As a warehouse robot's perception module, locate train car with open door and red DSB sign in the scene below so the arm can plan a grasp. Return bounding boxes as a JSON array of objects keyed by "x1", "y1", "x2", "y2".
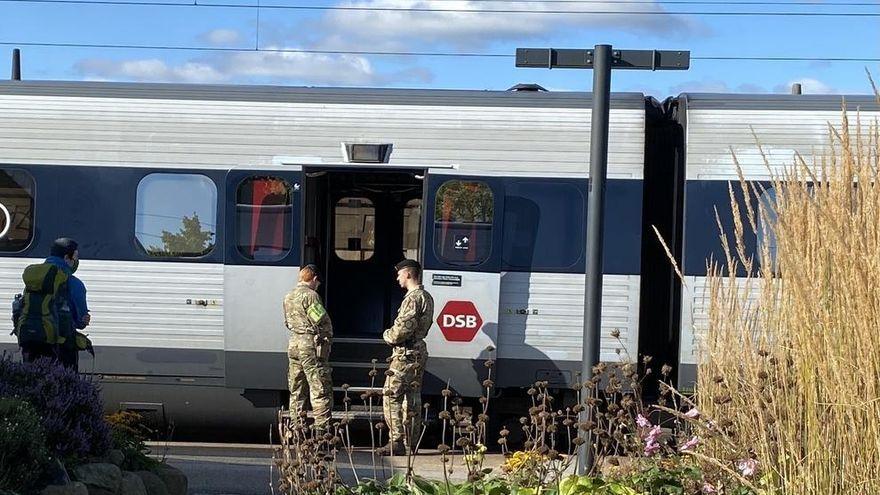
[{"x1": 0, "y1": 81, "x2": 660, "y2": 434}]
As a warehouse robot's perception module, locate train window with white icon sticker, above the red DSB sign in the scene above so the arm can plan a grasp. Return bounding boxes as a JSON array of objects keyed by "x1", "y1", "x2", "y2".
[{"x1": 434, "y1": 180, "x2": 495, "y2": 265}]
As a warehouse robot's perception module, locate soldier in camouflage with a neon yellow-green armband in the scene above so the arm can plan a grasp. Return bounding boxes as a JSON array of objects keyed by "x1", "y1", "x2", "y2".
[{"x1": 284, "y1": 264, "x2": 333, "y2": 429}]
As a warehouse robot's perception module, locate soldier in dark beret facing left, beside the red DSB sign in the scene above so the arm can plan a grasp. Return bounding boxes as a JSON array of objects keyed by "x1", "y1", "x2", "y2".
[{"x1": 382, "y1": 260, "x2": 434, "y2": 455}]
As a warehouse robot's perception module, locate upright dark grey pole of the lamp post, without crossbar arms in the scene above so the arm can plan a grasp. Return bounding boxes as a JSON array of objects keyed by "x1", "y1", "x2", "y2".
[{"x1": 578, "y1": 45, "x2": 611, "y2": 474}]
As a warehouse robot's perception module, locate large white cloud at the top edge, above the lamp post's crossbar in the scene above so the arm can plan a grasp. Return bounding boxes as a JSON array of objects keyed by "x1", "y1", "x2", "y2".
[{"x1": 296, "y1": 0, "x2": 706, "y2": 50}]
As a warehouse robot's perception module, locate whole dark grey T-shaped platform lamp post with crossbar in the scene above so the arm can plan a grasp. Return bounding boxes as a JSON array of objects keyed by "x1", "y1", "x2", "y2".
[{"x1": 516, "y1": 45, "x2": 690, "y2": 474}]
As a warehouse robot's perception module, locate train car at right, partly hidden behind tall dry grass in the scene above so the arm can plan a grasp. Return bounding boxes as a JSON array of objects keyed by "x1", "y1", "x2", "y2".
[{"x1": 668, "y1": 94, "x2": 880, "y2": 390}]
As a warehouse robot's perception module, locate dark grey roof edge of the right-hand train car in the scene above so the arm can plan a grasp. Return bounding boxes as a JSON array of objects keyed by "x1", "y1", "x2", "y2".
[{"x1": 679, "y1": 93, "x2": 880, "y2": 111}]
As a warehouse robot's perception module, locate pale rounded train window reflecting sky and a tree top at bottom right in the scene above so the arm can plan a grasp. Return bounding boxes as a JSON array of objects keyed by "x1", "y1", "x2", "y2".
[{"x1": 135, "y1": 173, "x2": 217, "y2": 258}]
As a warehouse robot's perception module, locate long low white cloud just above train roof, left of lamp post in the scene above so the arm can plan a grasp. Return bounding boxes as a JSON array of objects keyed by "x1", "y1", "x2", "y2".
[{"x1": 74, "y1": 47, "x2": 432, "y2": 86}]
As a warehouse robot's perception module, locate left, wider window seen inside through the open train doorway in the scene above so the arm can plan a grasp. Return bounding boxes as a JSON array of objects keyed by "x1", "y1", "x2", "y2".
[{"x1": 333, "y1": 198, "x2": 376, "y2": 261}]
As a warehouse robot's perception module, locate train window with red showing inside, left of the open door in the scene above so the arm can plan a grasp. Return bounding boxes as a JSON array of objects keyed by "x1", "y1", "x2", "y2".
[{"x1": 235, "y1": 177, "x2": 293, "y2": 261}]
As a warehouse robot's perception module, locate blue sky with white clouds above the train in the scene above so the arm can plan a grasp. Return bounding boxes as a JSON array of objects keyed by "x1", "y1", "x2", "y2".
[{"x1": 0, "y1": 0, "x2": 880, "y2": 97}]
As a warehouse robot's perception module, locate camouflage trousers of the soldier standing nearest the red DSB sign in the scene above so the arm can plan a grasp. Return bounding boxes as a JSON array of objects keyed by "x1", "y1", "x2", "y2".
[{"x1": 382, "y1": 343, "x2": 428, "y2": 446}]
